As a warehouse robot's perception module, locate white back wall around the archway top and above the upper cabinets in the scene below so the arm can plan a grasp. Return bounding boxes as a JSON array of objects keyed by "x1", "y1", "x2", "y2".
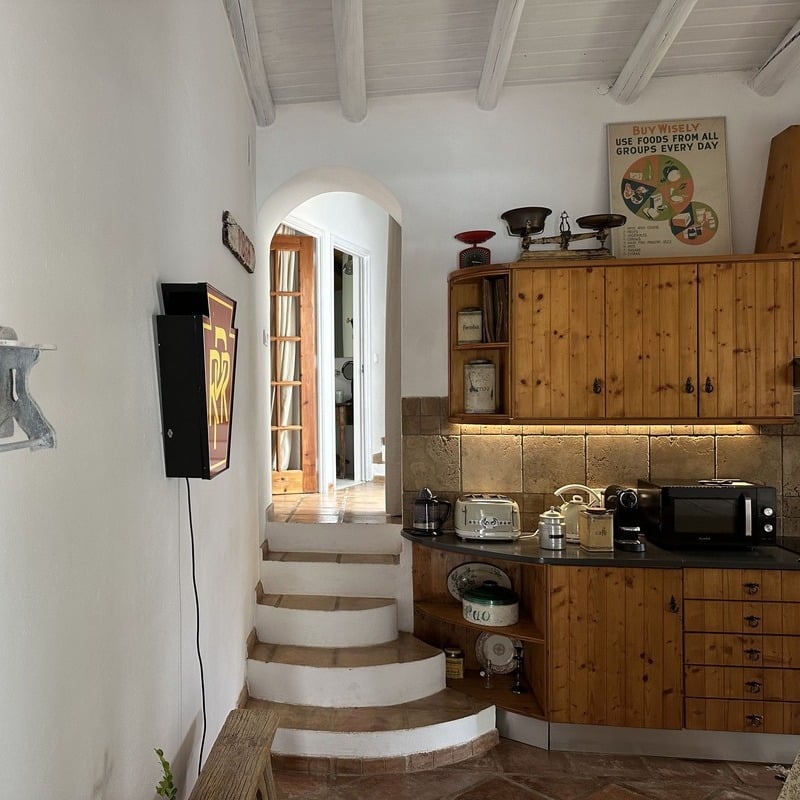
[{"x1": 257, "y1": 74, "x2": 800, "y2": 396}]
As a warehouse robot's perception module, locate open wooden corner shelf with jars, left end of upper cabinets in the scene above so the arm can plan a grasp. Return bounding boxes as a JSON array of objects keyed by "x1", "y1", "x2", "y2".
[{"x1": 449, "y1": 266, "x2": 511, "y2": 424}]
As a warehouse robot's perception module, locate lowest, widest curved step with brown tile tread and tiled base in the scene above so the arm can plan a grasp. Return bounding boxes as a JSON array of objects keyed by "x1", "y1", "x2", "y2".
[{"x1": 247, "y1": 689, "x2": 498, "y2": 772}]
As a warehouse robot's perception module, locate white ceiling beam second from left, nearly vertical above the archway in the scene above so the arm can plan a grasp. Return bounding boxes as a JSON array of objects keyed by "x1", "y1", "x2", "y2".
[{"x1": 332, "y1": 0, "x2": 367, "y2": 122}]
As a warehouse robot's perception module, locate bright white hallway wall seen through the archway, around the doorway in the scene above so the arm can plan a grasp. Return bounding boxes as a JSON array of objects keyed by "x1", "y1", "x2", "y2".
[{"x1": 292, "y1": 192, "x2": 389, "y2": 472}]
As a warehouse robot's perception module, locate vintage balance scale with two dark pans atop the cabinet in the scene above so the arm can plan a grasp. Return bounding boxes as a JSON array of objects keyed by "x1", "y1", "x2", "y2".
[{"x1": 500, "y1": 206, "x2": 627, "y2": 261}]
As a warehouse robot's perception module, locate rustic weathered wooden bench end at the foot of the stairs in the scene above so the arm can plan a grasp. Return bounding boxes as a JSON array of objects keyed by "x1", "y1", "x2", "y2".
[{"x1": 189, "y1": 708, "x2": 278, "y2": 800}]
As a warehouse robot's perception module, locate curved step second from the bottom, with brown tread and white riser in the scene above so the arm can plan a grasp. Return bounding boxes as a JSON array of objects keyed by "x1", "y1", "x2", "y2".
[{"x1": 247, "y1": 632, "x2": 445, "y2": 708}]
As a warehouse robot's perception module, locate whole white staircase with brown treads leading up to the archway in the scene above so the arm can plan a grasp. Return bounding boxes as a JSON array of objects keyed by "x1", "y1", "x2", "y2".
[{"x1": 247, "y1": 522, "x2": 498, "y2": 771}]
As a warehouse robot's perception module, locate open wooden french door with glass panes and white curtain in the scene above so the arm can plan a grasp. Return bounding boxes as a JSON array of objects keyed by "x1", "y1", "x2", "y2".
[{"x1": 270, "y1": 234, "x2": 317, "y2": 494}]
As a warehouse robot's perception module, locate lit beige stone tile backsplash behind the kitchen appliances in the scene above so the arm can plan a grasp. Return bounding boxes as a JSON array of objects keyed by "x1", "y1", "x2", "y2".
[{"x1": 403, "y1": 395, "x2": 800, "y2": 531}]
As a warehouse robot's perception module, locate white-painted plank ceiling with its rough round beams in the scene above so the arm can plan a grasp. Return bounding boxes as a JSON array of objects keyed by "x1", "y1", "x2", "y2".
[{"x1": 224, "y1": 0, "x2": 800, "y2": 125}]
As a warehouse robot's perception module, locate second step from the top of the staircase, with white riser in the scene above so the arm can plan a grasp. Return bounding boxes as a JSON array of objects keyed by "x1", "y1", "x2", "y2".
[{"x1": 261, "y1": 548, "x2": 408, "y2": 597}]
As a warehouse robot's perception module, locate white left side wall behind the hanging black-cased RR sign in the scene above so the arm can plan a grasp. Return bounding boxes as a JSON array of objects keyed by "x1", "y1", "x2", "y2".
[{"x1": 0, "y1": 0, "x2": 258, "y2": 800}]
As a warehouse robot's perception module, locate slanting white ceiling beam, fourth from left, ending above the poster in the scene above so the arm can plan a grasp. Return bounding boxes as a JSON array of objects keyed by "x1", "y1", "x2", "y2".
[{"x1": 609, "y1": 0, "x2": 697, "y2": 105}]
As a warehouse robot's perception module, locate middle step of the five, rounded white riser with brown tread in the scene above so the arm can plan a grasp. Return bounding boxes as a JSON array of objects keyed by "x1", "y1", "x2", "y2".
[{"x1": 256, "y1": 592, "x2": 397, "y2": 647}]
